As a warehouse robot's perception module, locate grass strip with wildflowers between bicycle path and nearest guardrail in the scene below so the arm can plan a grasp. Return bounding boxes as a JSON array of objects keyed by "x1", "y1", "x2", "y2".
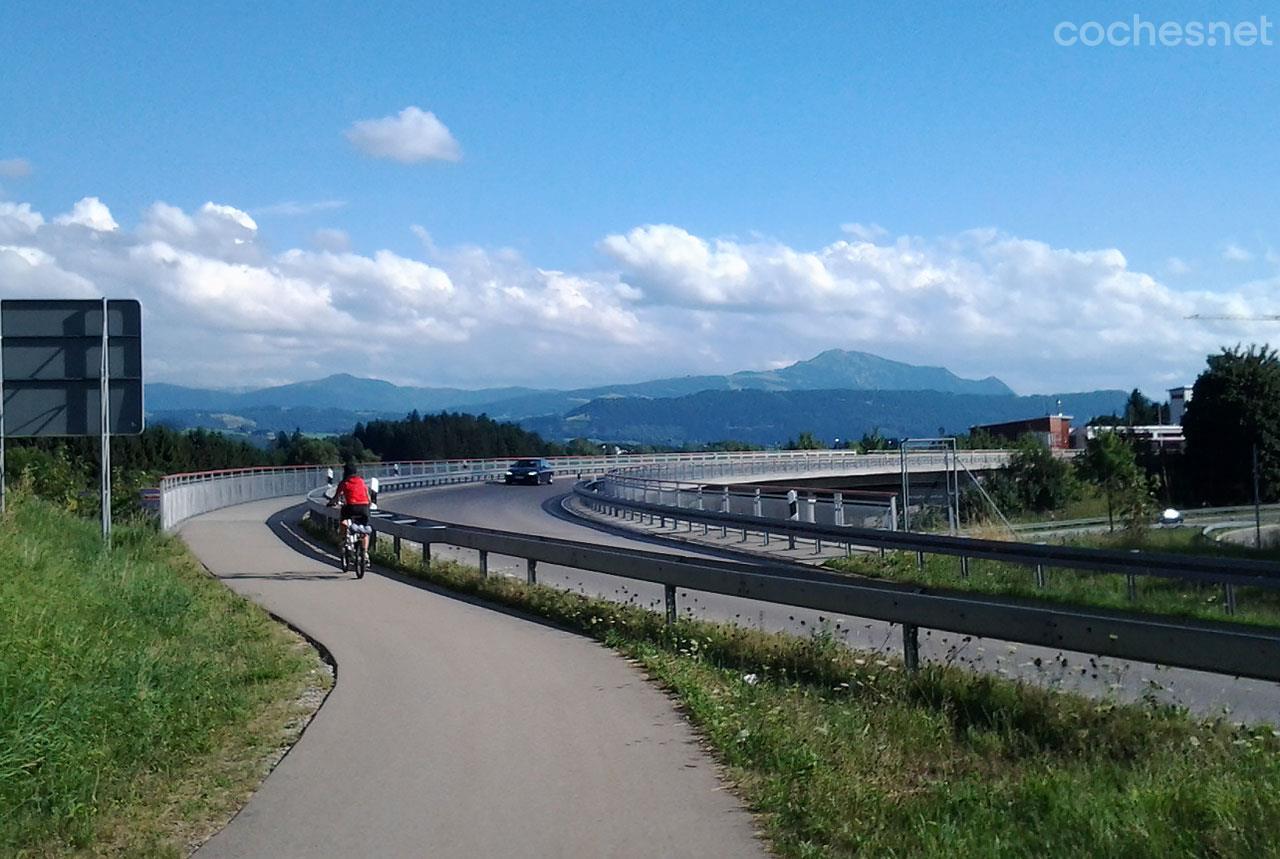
[{"x1": 302, "y1": 517, "x2": 1280, "y2": 858}]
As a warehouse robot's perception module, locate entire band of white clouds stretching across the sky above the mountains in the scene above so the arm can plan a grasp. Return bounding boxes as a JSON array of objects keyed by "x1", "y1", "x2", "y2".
[{"x1": 0, "y1": 198, "x2": 1264, "y2": 392}]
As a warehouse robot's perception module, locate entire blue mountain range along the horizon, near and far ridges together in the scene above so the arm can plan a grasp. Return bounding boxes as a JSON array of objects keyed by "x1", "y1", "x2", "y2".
[{"x1": 146, "y1": 349, "x2": 1125, "y2": 444}]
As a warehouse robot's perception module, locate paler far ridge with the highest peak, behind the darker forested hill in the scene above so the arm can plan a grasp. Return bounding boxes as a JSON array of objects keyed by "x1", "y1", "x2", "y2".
[{"x1": 147, "y1": 349, "x2": 1012, "y2": 431}]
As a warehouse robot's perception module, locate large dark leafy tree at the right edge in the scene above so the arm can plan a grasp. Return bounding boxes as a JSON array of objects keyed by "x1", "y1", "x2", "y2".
[{"x1": 1183, "y1": 346, "x2": 1280, "y2": 503}]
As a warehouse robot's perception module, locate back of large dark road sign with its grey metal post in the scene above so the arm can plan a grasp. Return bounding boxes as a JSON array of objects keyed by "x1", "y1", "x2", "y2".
[{"x1": 0, "y1": 298, "x2": 143, "y2": 542}]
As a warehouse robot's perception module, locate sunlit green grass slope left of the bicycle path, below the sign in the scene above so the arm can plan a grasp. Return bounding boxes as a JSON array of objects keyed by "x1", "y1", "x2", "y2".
[{"x1": 0, "y1": 494, "x2": 329, "y2": 856}]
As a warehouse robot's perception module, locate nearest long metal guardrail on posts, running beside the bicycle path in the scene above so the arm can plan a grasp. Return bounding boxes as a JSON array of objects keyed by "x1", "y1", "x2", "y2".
[{"x1": 307, "y1": 480, "x2": 1280, "y2": 681}]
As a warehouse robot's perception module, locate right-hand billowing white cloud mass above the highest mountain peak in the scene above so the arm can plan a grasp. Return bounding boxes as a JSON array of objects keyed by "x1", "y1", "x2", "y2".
[{"x1": 600, "y1": 225, "x2": 1274, "y2": 392}]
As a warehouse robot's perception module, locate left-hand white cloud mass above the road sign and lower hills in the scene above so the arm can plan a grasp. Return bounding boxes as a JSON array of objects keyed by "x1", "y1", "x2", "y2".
[{"x1": 0, "y1": 202, "x2": 662, "y2": 385}]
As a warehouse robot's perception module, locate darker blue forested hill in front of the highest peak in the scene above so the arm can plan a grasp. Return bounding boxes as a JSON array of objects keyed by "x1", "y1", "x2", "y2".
[{"x1": 521, "y1": 390, "x2": 1126, "y2": 444}]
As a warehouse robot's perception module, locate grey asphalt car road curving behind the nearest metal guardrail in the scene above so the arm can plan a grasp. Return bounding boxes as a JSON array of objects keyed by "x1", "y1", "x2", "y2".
[{"x1": 383, "y1": 484, "x2": 1280, "y2": 723}]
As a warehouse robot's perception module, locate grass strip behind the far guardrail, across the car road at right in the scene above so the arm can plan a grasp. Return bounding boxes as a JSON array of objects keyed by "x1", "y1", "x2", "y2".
[{"x1": 826, "y1": 527, "x2": 1280, "y2": 626}]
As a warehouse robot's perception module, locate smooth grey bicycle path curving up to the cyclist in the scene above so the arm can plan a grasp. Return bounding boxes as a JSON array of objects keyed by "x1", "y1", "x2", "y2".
[{"x1": 179, "y1": 499, "x2": 767, "y2": 859}]
